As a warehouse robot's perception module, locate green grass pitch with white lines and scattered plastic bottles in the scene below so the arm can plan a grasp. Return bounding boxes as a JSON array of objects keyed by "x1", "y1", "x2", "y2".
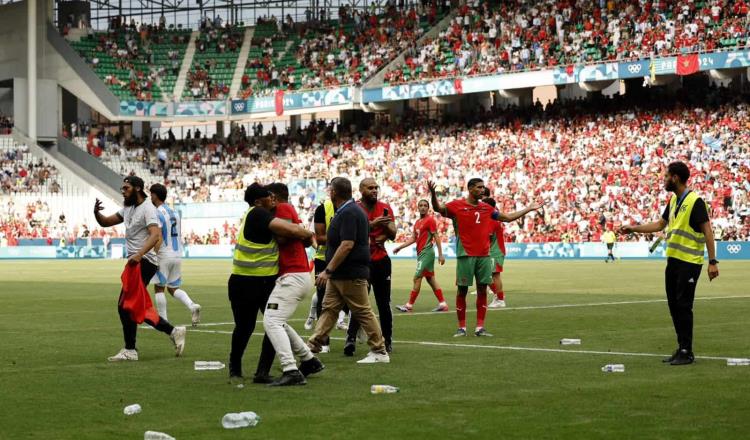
[{"x1": 0, "y1": 260, "x2": 750, "y2": 440}]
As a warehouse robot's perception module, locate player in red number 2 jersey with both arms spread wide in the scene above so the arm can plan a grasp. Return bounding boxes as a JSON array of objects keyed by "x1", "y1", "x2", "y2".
[{"x1": 427, "y1": 178, "x2": 541, "y2": 337}]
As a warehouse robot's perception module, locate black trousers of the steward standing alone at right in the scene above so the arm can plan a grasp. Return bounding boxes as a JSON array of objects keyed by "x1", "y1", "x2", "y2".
[{"x1": 664, "y1": 258, "x2": 703, "y2": 352}]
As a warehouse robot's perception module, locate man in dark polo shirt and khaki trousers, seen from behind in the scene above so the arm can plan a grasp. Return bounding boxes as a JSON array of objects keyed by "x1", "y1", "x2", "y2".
[{"x1": 308, "y1": 177, "x2": 390, "y2": 364}]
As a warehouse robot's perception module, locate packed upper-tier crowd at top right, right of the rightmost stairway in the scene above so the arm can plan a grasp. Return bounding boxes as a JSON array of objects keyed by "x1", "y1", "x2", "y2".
[{"x1": 384, "y1": 0, "x2": 750, "y2": 83}]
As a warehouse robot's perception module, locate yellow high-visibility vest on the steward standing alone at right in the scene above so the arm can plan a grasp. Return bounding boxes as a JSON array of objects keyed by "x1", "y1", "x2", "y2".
[{"x1": 667, "y1": 192, "x2": 706, "y2": 264}]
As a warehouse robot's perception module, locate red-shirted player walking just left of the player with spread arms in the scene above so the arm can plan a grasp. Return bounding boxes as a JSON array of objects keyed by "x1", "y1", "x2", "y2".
[{"x1": 393, "y1": 199, "x2": 448, "y2": 312}]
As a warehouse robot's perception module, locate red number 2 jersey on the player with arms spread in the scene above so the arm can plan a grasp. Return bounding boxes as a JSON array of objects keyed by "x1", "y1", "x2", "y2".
[{"x1": 445, "y1": 199, "x2": 496, "y2": 257}]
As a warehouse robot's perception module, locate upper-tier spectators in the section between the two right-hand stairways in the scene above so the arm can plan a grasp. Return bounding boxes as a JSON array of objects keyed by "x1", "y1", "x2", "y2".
[{"x1": 241, "y1": 1, "x2": 447, "y2": 96}]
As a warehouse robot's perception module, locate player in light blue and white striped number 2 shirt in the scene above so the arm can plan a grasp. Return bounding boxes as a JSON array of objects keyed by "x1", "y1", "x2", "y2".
[{"x1": 149, "y1": 183, "x2": 201, "y2": 326}]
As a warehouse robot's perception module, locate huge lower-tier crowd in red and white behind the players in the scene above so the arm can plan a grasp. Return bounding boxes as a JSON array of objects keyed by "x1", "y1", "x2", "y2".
[{"x1": 47, "y1": 84, "x2": 750, "y2": 246}]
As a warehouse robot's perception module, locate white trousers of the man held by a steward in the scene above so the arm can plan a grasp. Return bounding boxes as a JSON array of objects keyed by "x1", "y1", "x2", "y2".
[{"x1": 263, "y1": 272, "x2": 313, "y2": 371}]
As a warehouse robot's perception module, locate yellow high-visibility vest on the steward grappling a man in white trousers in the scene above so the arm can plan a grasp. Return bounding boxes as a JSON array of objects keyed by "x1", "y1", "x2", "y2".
[{"x1": 232, "y1": 208, "x2": 279, "y2": 277}]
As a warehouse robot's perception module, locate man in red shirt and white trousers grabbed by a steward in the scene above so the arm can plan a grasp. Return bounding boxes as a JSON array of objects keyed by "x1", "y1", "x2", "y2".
[{"x1": 263, "y1": 183, "x2": 325, "y2": 386}]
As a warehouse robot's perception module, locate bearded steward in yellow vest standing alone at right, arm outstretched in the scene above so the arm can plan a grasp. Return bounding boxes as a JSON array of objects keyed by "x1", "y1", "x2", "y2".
[{"x1": 621, "y1": 162, "x2": 719, "y2": 365}]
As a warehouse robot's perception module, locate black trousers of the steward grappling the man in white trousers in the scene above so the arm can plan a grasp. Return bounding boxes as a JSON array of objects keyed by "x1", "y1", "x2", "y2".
[{"x1": 228, "y1": 274, "x2": 277, "y2": 376}]
